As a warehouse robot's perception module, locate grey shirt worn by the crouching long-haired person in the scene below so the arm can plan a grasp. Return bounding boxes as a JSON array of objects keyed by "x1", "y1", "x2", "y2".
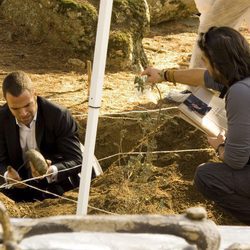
[{"x1": 204, "y1": 71, "x2": 250, "y2": 169}]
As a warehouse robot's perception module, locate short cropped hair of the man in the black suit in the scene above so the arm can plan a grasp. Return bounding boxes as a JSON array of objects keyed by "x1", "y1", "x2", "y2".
[{"x1": 2, "y1": 71, "x2": 33, "y2": 98}]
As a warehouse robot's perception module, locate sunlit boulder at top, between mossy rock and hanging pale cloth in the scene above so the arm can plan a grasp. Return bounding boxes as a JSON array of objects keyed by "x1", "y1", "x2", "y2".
[{"x1": 147, "y1": 0, "x2": 197, "y2": 24}]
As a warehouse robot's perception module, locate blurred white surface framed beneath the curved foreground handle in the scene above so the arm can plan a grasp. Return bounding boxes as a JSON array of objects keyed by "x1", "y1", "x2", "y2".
[{"x1": 19, "y1": 232, "x2": 191, "y2": 250}]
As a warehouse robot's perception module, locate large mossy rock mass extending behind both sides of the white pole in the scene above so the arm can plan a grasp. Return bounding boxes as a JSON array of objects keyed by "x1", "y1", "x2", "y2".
[{"x1": 1, "y1": 0, "x2": 149, "y2": 70}]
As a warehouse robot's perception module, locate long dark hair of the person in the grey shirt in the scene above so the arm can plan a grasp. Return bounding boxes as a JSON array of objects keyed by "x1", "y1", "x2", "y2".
[{"x1": 198, "y1": 27, "x2": 250, "y2": 86}]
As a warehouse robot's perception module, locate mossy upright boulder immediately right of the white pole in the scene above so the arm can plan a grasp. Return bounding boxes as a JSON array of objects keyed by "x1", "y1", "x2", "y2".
[{"x1": 108, "y1": 0, "x2": 150, "y2": 70}]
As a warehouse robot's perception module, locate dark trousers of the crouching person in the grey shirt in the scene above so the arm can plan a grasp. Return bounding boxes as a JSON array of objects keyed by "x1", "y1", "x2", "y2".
[{"x1": 194, "y1": 163, "x2": 250, "y2": 225}]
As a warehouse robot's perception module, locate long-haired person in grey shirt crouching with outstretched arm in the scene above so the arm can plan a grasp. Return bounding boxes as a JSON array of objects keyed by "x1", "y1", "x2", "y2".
[{"x1": 142, "y1": 27, "x2": 250, "y2": 224}]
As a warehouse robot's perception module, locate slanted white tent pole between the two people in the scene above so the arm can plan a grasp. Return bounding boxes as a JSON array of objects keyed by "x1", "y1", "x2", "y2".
[{"x1": 76, "y1": 0, "x2": 113, "y2": 215}]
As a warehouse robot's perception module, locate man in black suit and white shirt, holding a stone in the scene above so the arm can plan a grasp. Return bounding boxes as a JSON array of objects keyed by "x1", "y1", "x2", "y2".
[{"x1": 0, "y1": 71, "x2": 82, "y2": 201}]
